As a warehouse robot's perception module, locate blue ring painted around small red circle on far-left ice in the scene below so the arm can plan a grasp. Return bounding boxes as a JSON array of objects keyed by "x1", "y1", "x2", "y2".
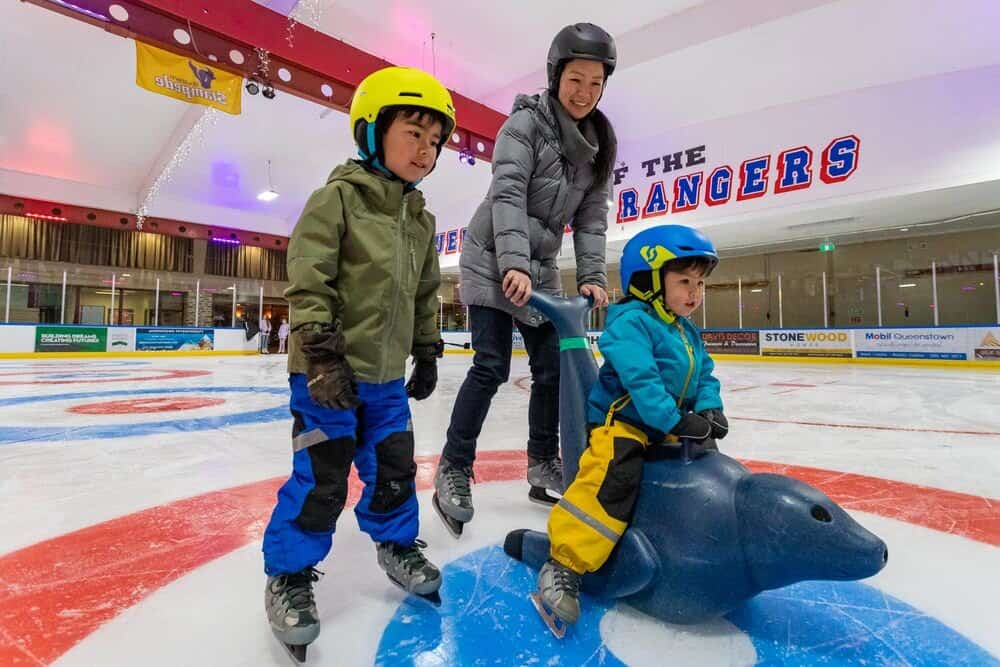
[{"x1": 0, "y1": 387, "x2": 289, "y2": 445}]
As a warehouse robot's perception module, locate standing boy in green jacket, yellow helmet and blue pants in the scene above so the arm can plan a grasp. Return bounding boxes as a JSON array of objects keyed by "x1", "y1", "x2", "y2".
[{"x1": 264, "y1": 67, "x2": 455, "y2": 658}]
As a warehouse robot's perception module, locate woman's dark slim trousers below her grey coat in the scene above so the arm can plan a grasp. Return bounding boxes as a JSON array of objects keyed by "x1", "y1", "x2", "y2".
[{"x1": 441, "y1": 306, "x2": 559, "y2": 466}]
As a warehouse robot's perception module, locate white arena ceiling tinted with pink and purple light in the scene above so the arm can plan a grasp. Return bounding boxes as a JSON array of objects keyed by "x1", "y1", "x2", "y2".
[{"x1": 0, "y1": 0, "x2": 1000, "y2": 276}]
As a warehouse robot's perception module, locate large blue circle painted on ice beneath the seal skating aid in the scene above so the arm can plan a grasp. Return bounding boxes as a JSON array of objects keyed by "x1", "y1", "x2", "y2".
[{"x1": 375, "y1": 546, "x2": 1000, "y2": 667}]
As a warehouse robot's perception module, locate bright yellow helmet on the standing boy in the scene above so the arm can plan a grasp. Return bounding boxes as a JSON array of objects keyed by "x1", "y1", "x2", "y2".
[{"x1": 350, "y1": 67, "x2": 455, "y2": 160}]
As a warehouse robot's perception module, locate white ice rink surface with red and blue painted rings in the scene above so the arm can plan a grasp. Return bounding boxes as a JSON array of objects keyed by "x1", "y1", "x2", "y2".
[{"x1": 0, "y1": 355, "x2": 1000, "y2": 667}]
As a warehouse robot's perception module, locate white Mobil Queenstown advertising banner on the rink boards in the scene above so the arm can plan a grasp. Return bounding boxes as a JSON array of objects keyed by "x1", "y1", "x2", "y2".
[{"x1": 854, "y1": 328, "x2": 968, "y2": 360}]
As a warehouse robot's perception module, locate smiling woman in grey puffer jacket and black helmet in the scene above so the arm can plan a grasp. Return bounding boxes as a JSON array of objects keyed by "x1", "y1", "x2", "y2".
[{"x1": 434, "y1": 23, "x2": 617, "y2": 537}]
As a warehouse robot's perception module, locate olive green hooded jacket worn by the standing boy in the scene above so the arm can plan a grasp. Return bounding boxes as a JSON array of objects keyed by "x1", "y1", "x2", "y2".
[{"x1": 285, "y1": 160, "x2": 441, "y2": 383}]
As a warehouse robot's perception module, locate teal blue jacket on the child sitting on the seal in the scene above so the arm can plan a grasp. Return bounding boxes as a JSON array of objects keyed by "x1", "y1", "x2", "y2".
[{"x1": 587, "y1": 300, "x2": 722, "y2": 438}]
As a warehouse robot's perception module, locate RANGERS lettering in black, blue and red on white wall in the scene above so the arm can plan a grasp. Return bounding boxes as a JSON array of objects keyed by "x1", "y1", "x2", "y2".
[{"x1": 614, "y1": 134, "x2": 861, "y2": 224}]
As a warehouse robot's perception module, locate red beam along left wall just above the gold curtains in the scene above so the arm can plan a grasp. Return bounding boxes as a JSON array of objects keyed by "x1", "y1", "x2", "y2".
[{"x1": 0, "y1": 194, "x2": 288, "y2": 250}]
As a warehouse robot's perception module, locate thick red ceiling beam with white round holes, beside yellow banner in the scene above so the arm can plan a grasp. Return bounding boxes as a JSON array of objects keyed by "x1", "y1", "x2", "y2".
[{"x1": 24, "y1": 0, "x2": 506, "y2": 160}]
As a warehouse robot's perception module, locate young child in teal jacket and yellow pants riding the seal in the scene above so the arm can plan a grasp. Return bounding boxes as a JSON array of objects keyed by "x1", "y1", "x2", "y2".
[{"x1": 537, "y1": 225, "x2": 729, "y2": 624}]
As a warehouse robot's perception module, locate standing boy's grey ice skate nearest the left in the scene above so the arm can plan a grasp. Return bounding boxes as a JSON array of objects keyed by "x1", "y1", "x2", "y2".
[{"x1": 264, "y1": 567, "x2": 322, "y2": 662}]
